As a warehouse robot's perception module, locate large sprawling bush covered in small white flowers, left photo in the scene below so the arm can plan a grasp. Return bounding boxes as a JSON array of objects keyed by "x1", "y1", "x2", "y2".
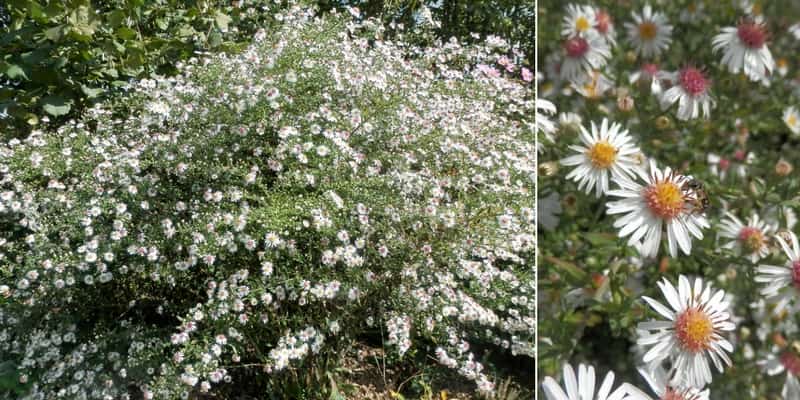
[{"x1": 0, "y1": 3, "x2": 536, "y2": 399}]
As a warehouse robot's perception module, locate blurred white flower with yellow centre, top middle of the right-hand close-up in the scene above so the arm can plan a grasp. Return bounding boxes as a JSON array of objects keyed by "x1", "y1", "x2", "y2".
[{"x1": 625, "y1": 4, "x2": 672, "y2": 58}]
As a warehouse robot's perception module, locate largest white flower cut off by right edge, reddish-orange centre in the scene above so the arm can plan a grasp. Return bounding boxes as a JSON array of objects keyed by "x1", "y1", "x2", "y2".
[{"x1": 755, "y1": 231, "x2": 800, "y2": 312}]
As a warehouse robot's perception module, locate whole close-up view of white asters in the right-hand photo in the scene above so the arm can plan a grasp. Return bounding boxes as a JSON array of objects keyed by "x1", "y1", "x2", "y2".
[{"x1": 536, "y1": 0, "x2": 800, "y2": 400}]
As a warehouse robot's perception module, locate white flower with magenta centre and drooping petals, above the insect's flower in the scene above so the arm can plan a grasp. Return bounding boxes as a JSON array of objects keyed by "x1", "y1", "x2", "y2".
[{"x1": 658, "y1": 66, "x2": 716, "y2": 121}]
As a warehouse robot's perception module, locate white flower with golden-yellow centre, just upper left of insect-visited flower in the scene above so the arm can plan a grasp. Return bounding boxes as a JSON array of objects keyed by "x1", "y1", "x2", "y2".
[{"x1": 561, "y1": 118, "x2": 642, "y2": 197}]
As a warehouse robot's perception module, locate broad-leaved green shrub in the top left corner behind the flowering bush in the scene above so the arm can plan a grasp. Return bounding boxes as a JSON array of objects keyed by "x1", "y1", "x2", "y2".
[{"x1": 0, "y1": 0, "x2": 280, "y2": 137}]
